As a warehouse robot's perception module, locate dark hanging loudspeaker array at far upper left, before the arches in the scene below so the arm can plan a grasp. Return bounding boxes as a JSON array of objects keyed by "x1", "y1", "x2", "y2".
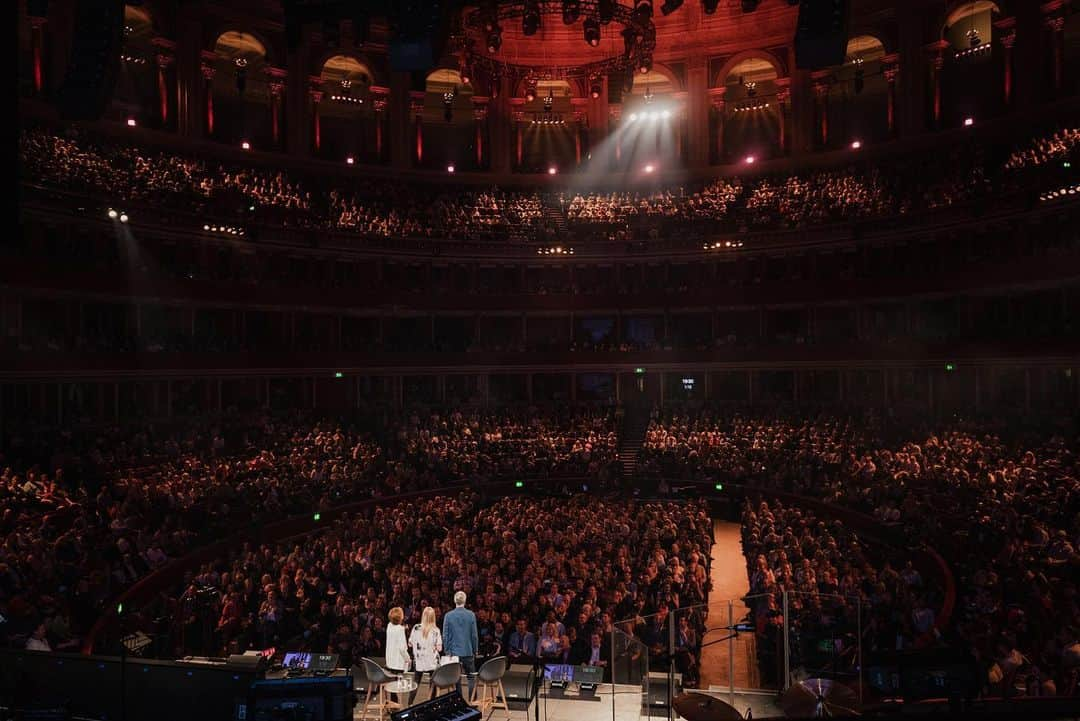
[{"x1": 57, "y1": 0, "x2": 124, "y2": 120}]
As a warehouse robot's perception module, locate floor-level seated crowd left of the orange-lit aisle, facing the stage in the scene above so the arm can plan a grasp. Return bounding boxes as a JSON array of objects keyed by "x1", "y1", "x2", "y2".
[{"x1": 164, "y1": 494, "x2": 712, "y2": 683}]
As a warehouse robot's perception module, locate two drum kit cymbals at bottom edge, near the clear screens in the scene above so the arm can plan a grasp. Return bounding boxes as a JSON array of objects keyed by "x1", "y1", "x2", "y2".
[{"x1": 672, "y1": 679, "x2": 860, "y2": 721}]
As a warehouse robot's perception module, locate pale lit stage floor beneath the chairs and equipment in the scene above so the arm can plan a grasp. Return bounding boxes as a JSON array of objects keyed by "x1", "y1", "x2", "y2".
[{"x1": 353, "y1": 683, "x2": 783, "y2": 721}]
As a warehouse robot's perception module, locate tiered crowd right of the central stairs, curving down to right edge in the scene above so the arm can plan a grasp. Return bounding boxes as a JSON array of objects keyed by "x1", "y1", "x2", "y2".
[{"x1": 642, "y1": 411, "x2": 1080, "y2": 695}]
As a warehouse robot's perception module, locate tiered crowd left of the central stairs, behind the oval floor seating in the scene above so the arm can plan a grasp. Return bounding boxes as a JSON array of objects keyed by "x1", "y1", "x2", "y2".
[{"x1": 0, "y1": 409, "x2": 616, "y2": 648}]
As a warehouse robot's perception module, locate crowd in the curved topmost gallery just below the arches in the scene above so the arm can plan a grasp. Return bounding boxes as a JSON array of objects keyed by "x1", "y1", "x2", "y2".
[{"x1": 19, "y1": 123, "x2": 1080, "y2": 241}]
